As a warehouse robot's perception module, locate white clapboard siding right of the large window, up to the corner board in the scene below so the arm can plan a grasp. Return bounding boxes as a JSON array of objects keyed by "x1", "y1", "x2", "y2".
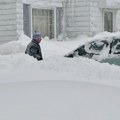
[{"x1": 66, "y1": 0, "x2": 90, "y2": 37}]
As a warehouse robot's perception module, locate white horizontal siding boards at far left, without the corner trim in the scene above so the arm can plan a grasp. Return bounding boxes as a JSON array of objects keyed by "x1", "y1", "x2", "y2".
[{"x1": 0, "y1": 0, "x2": 16, "y2": 43}]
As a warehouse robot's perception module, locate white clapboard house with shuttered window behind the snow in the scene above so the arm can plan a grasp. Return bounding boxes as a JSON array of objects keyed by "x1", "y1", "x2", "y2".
[{"x1": 0, "y1": 0, "x2": 120, "y2": 43}]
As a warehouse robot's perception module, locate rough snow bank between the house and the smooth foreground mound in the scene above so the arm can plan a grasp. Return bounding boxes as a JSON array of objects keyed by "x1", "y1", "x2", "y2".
[{"x1": 0, "y1": 33, "x2": 120, "y2": 87}]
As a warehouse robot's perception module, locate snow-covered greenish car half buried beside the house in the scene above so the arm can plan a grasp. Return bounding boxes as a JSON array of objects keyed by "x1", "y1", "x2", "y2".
[{"x1": 65, "y1": 36, "x2": 120, "y2": 65}]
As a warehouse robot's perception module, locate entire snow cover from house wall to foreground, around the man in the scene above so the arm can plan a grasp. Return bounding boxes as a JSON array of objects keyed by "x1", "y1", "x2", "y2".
[{"x1": 0, "y1": 32, "x2": 120, "y2": 120}]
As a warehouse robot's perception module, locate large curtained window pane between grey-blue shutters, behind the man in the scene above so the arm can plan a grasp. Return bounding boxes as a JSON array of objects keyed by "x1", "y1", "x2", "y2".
[{"x1": 32, "y1": 8, "x2": 54, "y2": 39}]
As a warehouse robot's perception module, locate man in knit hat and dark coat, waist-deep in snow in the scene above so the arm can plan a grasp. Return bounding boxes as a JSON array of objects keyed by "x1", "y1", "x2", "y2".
[{"x1": 25, "y1": 32, "x2": 43, "y2": 60}]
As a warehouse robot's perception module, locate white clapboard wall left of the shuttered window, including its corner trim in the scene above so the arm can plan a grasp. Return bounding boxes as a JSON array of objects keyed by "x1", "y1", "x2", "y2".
[{"x1": 0, "y1": 0, "x2": 23, "y2": 44}]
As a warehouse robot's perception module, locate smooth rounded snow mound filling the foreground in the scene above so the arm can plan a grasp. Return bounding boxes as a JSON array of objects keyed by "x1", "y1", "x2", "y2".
[{"x1": 0, "y1": 81, "x2": 120, "y2": 120}]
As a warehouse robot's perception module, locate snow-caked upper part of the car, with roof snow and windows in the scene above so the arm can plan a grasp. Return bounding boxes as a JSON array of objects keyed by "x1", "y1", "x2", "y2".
[{"x1": 65, "y1": 32, "x2": 120, "y2": 61}]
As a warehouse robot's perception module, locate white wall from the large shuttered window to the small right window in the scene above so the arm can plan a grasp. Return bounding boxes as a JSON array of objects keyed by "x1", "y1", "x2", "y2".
[{"x1": 66, "y1": 0, "x2": 106, "y2": 37}]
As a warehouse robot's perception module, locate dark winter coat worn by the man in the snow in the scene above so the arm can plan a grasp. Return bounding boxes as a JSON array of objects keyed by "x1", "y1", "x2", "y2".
[{"x1": 25, "y1": 40, "x2": 43, "y2": 60}]
